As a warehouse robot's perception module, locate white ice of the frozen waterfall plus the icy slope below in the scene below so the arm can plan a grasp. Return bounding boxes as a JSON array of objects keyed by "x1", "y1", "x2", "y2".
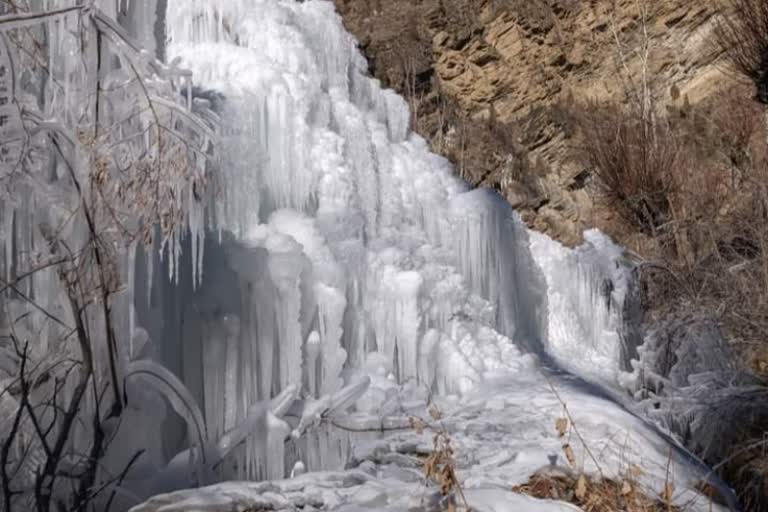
[{"x1": 0, "y1": 0, "x2": 736, "y2": 512}]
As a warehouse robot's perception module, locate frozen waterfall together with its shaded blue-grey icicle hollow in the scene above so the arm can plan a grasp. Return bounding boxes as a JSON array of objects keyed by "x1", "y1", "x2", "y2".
[{"x1": 0, "y1": 0, "x2": 732, "y2": 506}]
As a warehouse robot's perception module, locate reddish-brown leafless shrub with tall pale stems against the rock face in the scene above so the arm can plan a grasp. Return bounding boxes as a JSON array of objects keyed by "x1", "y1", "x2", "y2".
[{"x1": 567, "y1": 0, "x2": 689, "y2": 236}]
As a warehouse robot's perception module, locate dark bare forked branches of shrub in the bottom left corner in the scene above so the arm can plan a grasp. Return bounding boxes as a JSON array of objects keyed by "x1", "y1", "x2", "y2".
[{"x1": 0, "y1": 326, "x2": 142, "y2": 512}]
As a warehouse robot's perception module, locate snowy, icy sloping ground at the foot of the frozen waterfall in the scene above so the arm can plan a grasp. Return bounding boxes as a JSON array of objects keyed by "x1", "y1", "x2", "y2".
[{"x1": 132, "y1": 356, "x2": 721, "y2": 512}]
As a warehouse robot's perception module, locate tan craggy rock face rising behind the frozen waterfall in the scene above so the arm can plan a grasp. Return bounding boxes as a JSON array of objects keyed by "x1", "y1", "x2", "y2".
[{"x1": 335, "y1": 0, "x2": 725, "y2": 244}]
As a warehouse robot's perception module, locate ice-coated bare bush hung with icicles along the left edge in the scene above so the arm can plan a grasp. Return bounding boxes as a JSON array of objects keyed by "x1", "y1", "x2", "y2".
[{"x1": 0, "y1": 6, "x2": 215, "y2": 512}]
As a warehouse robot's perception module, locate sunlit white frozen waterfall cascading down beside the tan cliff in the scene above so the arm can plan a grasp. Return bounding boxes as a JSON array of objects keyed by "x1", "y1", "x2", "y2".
[{"x1": 150, "y1": 0, "x2": 640, "y2": 408}]
